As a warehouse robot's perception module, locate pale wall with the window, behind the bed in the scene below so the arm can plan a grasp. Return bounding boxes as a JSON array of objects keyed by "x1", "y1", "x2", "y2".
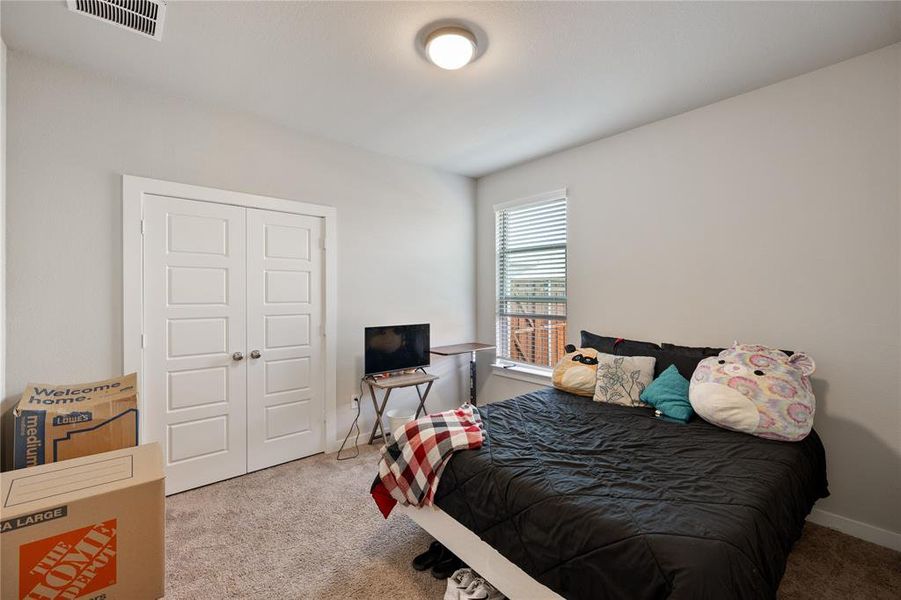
[{"x1": 477, "y1": 46, "x2": 901, "y2": 543}]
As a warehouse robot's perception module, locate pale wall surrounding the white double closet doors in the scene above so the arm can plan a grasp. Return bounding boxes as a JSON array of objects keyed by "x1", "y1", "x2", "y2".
[{"x1": 5, "y1": 51, "x2": 475, "y2": 464}]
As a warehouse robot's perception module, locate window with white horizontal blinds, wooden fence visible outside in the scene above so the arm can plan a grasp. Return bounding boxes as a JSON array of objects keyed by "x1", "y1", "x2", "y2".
[{"x1": 496, "y1": 195, "x2": 566, "y2": 367}]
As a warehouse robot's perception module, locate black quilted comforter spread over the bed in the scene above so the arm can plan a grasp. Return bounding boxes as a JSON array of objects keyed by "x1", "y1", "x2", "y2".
[{"x1": 436, "y1": 389, "x2": 828, "y2": 600}]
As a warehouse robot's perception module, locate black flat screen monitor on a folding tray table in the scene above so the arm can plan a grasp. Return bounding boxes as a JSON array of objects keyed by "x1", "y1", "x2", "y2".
[{"x1": 363, "y1": 323, "x2": 429, "y2": 375}]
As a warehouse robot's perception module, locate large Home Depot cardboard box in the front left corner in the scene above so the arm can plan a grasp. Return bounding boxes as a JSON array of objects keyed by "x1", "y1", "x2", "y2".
[{"x1": 0, "y1": 444, "x2": 166, "y2": 600}]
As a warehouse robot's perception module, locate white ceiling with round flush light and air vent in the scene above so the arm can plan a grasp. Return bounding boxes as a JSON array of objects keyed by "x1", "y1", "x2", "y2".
[{"x1": 0, "y1": 0, "x2": 901, "y2": 177}]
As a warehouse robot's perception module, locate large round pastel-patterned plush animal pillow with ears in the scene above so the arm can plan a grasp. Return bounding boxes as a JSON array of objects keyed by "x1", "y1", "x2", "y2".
[{"x1": 688, "y1": 344, "x2": 816, "y2": 442}]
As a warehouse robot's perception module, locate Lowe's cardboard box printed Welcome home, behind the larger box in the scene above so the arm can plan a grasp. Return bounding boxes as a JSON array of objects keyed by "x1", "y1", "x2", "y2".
[{"x1": 13, "y1": 373, "x2": 138, "y2": 469}]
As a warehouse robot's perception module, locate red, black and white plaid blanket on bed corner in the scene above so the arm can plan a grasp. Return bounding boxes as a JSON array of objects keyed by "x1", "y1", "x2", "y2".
[{"x1": 370, "y1": 404, "x2": 484, "y2": 519}]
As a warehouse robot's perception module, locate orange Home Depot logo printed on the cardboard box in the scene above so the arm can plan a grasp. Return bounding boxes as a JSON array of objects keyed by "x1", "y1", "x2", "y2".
[{"x1": 19, "y1": 519, "x2": 116, "y2": 600}]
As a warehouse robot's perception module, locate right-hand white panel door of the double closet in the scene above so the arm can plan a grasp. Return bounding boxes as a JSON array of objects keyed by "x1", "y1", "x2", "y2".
[{"x1": 247, "y1": 209, "x2": 325, "y2": 471}]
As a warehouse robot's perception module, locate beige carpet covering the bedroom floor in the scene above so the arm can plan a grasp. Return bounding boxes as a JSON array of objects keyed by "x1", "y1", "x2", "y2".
[{"x1": 166, "y1": 447, "x2": 901, "y2": 600}]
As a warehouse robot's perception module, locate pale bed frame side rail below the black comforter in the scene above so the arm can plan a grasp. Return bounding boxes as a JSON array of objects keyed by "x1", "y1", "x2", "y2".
[{"x1": 394, "y1": 504, "x2": 563, "y2": 600}]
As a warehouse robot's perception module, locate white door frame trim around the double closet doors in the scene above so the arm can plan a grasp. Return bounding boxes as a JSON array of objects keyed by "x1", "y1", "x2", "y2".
[{"x1": 122, "y1": 174, "x2": 338, "y2": 452}]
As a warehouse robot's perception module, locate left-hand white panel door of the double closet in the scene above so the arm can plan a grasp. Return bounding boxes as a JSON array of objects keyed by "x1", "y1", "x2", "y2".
[{"x1": 142, "y1": 195, "x2": 247, "y2": 494}]
